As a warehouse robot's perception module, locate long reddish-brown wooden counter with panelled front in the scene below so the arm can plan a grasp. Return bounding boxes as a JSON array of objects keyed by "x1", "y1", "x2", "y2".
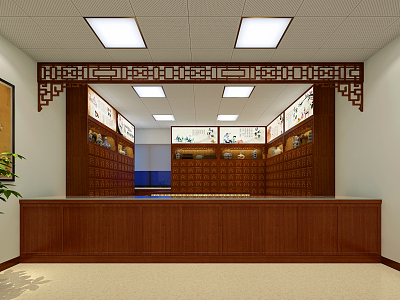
[{"x1": 20, "y1": 197, "x2": 382, "y2": 262}]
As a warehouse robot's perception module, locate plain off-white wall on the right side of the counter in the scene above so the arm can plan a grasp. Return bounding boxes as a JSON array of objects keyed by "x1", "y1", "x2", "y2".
[{"x1": 335, "y1": 38, "x2": 400, "y2": 262}]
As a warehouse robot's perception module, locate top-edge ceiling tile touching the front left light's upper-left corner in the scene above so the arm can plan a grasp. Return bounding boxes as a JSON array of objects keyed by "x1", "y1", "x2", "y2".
[{"x1": 13, "y1": 0, "x2": 80, "y2": 17}]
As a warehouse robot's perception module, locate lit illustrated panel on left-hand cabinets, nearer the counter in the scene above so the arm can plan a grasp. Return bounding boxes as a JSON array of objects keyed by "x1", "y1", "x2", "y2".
[{"x1": 88, "y1": 87, "x2": 117, "y2": 131}]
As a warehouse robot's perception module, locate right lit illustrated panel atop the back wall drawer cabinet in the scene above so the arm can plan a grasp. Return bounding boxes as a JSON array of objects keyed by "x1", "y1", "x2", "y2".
[{"x1": 219, "y1": 127, "x2": 265, "y2": 144}]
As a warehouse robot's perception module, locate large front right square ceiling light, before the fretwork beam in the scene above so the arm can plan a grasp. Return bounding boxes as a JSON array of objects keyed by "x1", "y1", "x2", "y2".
[{"x1": 235, "y1": 18, "x2": 293, "y2": 48}]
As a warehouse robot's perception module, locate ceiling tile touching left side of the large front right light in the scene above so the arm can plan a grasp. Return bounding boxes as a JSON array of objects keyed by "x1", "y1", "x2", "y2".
[{"x1": 189, "y1": 17, "x2": 240, "y2": 48}]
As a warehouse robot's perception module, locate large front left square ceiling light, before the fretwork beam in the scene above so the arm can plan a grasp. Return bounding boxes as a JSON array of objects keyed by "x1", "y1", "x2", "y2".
[{"x1": 85, "y1": 18, "x2": 146, "y2": 48}]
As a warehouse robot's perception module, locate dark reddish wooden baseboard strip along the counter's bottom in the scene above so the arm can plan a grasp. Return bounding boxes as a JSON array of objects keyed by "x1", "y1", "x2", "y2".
[{"x1": 21, "y1": 255, "x2": 381, "y2": 263}]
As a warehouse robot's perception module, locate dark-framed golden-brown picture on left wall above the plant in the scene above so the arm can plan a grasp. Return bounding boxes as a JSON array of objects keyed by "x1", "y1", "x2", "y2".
[{"x1": 0, "y1": 78, "x2": 15, "y2": 181}]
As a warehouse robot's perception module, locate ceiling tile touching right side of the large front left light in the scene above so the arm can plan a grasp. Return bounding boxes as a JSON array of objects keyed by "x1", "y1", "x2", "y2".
[{"x1": 137, "y1": 17, "x2": 190, "y2": 49}]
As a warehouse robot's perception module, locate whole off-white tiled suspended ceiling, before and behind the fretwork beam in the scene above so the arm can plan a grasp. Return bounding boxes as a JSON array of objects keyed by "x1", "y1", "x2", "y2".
[{"x1": 0, "y1": 0, "x2": 400, "y2": 128}]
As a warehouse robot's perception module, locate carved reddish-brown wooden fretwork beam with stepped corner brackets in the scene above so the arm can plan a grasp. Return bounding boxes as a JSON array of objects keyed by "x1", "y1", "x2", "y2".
[{"x1": 38, "y1": 63, "x2": 364, "y2": 111}]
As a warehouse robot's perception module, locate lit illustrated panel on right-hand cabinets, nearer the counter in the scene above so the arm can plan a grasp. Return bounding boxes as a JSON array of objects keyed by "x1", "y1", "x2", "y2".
[{"x1": 285, "y1": 88, "x2": 313, "y2": 131}]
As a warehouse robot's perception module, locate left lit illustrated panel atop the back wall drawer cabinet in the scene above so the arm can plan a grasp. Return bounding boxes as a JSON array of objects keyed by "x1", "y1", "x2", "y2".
[{"x1": 171, "y1": 127, "x2": 218, "y2": 144}]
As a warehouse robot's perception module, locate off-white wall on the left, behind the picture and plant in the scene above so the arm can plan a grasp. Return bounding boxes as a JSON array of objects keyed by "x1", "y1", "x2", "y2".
[{"x1": 0, "y1": 36, "x2": 66, "y2": 263}]
